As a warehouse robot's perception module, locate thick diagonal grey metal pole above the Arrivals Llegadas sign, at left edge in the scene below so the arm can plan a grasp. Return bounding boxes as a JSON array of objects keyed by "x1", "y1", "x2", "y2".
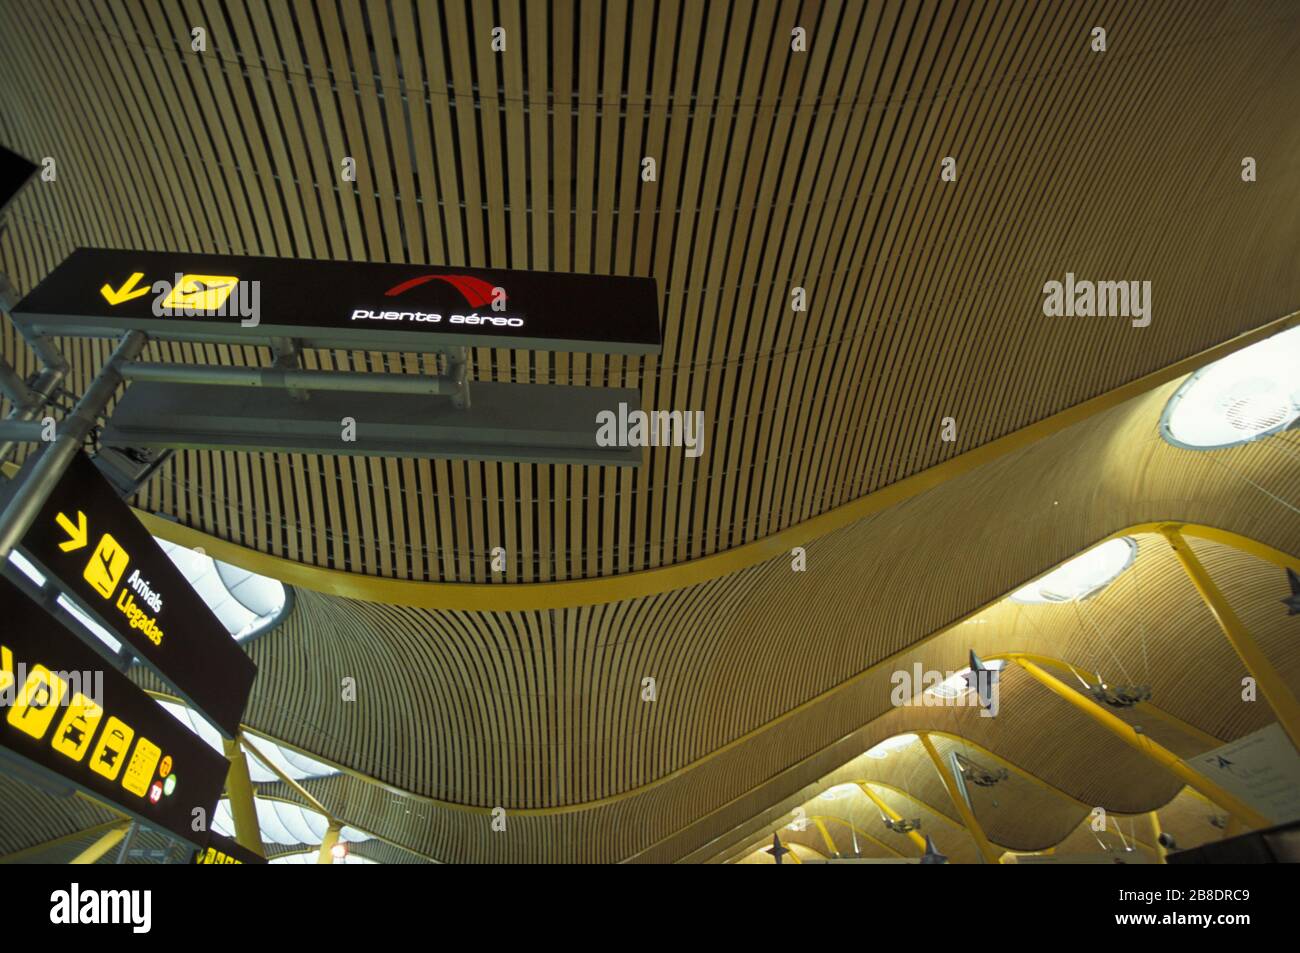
[{"x1": 0, "y1": 332, "x2": 147, "y2": 563}]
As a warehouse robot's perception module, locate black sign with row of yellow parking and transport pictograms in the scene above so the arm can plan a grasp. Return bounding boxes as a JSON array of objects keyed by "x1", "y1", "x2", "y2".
[{"x1": 0, "y1": 579, "x2": 230, "y2": 846}]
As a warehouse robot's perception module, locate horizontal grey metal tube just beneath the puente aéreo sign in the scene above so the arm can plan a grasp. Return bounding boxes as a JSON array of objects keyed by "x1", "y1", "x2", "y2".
[{"x1": 121, "y1": 363, "x2": 458, "y2": 395}]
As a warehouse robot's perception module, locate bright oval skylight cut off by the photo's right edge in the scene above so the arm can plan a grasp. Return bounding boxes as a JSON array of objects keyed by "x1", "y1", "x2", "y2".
[{"x1": 1160, "y1": 328, "x2": 1300, "y2": 450}]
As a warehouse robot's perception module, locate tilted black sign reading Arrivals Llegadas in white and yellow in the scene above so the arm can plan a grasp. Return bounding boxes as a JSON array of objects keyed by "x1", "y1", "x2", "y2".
[{"x1": 20, "y1": 454, "x2": 257, "y2": 737}]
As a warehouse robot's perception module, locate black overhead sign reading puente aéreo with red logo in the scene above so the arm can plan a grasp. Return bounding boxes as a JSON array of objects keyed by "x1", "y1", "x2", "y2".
[{"x1": 13, "y1": 248, "x2": 660, "y2": 354}]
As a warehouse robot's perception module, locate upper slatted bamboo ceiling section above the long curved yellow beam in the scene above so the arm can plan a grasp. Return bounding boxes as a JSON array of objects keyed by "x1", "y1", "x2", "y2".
[{"x1": 0, "y1": 0, "x2": 1300, "y2": 581}]
